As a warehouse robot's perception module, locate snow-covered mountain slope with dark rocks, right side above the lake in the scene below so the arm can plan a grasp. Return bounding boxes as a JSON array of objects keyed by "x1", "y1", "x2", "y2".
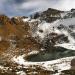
[{"x1": 29, "y1": 9, "x2": 75, "y2": 50}]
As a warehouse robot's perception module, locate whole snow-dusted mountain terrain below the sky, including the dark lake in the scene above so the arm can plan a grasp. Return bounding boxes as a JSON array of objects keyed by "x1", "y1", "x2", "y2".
[{"x1": 0, "y1": 8, "x2": 75, "y2": 75}]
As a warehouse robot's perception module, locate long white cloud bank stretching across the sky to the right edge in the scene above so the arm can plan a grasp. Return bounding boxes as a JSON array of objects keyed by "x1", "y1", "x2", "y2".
[{"x1": 18, "y1": 0, "x2": 75, "y2": 13}]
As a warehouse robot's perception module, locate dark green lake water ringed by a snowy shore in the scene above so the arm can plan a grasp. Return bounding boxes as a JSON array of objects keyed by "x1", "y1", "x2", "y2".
[{"x1": 27, "y1": 48, "x2": 75, "y2": 62}]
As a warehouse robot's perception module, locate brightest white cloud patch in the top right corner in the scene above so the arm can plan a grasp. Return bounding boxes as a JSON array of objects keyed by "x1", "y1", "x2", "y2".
[{"x1": 54, "y1": 0, "x2": 75, "y2": 10}]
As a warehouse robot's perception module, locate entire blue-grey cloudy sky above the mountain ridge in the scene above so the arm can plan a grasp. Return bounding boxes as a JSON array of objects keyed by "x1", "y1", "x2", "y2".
[{"x1": 0, "y1": 0, "x2": 75, "y2": 16}]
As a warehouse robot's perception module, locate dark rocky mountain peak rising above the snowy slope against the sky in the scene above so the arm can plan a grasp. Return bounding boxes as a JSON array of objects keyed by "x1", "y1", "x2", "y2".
[{"x1": 32, "y1": 8, "x2": 64, "y2": 23}]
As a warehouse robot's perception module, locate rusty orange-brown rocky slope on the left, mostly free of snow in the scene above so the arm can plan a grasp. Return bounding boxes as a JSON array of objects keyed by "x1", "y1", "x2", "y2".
[{"x1": 0, "y1": 15, "x2": 40, "y2": 61}]
